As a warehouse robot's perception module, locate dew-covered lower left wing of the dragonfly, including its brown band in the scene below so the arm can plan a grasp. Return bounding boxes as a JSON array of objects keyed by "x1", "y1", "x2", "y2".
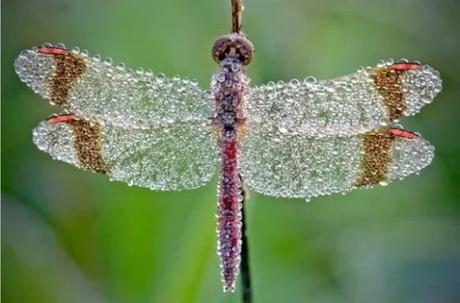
[{"x1": 33, "y1": 115, "x2": 218, "y2": 190}]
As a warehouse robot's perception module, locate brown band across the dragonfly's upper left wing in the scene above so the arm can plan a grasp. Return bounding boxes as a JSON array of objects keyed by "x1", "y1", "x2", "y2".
[{"x1": 50, "y1": 52, "x2": 87, "y2": 106}]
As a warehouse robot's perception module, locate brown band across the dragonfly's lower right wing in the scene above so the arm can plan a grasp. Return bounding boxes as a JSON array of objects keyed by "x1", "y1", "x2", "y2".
[{"x1": 353, "y1": 128, "x2": 395, "y2": 187}]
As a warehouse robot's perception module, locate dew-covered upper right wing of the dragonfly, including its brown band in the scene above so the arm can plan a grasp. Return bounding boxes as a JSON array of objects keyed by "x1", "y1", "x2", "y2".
[{"x1": 245, "y1": 61, "x2": 441, "y2": 136}]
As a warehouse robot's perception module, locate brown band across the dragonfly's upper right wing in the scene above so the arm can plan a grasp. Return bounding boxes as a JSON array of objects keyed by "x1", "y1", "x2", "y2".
[{"x1": 372, "y1": 66, "x2": 407, "y2": 121}]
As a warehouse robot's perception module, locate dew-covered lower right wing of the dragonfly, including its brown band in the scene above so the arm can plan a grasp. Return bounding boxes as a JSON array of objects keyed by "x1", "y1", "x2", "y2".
[{"x1": 239, "y1": 128, "x2": 434, "y2": 200}]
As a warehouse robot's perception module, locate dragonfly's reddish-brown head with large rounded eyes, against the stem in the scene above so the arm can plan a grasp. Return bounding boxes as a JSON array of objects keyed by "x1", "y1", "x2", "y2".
[{"x1": 212, "y1": 34, "x2": 254, "y2": 65}]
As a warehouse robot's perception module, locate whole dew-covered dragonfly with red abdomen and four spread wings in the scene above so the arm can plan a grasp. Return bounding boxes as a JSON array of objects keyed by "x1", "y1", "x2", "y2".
[{"x1": 15, "y1": 1, "x2": 441, "y2": 291}]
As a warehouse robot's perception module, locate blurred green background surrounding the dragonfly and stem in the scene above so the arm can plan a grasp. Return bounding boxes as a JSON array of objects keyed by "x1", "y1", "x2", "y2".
[{"x1": 2, "y1": 0, "x2": 460, "y2": 303}]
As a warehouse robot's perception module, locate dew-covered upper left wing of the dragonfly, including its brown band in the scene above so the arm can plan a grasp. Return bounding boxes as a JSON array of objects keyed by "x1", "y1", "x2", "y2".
[{"x1": 15, "y1": 46, "x2": 213, "y2": 128}]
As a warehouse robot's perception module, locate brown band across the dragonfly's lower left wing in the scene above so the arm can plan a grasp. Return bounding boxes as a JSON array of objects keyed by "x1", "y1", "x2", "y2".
[{"x1": 67, "y1": 119, "x2": 110, "y2": 174}]
